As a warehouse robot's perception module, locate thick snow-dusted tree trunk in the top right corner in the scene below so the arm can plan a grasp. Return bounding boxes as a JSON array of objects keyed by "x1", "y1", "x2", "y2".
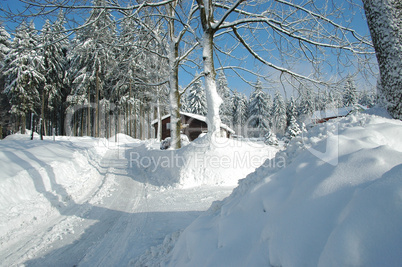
[{"x1": 363, "y1": 0, "x2": 402, "y2": 120}]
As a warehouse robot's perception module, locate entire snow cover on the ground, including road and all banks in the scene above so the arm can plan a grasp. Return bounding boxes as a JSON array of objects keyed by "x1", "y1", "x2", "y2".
[{"x1": 0, "y1": 110, "x2": 402, "y2": 266}]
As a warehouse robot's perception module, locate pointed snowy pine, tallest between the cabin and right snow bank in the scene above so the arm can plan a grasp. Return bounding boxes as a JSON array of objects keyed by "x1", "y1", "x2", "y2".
[{"x1": 247, "y1": 80, "x2": 272, "y2": 137}]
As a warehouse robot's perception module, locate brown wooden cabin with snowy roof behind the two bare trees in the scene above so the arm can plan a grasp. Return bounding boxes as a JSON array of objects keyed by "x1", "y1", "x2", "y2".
[{"x1": 152, "y1": 112, "x2": 235, "y2": 141}]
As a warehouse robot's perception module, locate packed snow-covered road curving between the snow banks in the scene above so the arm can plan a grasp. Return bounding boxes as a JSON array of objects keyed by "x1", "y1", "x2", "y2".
[{"x1": 0, "y1": 147, "x2": 233, "y2": 266}]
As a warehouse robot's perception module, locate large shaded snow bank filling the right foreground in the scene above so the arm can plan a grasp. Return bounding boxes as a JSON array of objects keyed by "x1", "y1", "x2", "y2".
[{"x1": 163, "y1": 115, "x2": 402, "y2": 266}]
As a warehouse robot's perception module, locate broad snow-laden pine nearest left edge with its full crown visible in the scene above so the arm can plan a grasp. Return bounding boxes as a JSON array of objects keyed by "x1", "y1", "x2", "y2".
[{"x1": 4, "y1": 22, "x2": 45, "y2": 132}]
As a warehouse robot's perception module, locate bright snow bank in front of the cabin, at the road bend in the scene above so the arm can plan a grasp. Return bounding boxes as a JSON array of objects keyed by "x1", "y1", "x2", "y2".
[{"x1": 127, "y1": 135, "x2": 277, "y2": 187}]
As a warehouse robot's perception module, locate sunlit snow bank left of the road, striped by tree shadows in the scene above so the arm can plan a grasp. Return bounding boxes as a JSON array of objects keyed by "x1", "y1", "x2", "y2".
[{"x1": 0, "y1": 134, "x2": 107, "y2": 243}]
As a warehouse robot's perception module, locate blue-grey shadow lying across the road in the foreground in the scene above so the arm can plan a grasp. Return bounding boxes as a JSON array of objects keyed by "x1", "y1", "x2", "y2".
[{"x1": 24, "y1": 210, "x2": 201, "y2": 267}]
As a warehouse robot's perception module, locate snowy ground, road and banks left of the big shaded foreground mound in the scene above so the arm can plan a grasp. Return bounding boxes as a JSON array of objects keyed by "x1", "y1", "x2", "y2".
[{"x1": 0, "y1": 135, "x2": 276, "y2": 266}]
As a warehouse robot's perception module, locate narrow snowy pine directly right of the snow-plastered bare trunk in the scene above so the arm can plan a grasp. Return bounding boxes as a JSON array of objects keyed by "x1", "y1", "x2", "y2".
[{"x1": 216, "y1": 71, "x2": 233, "y2": 125}]
